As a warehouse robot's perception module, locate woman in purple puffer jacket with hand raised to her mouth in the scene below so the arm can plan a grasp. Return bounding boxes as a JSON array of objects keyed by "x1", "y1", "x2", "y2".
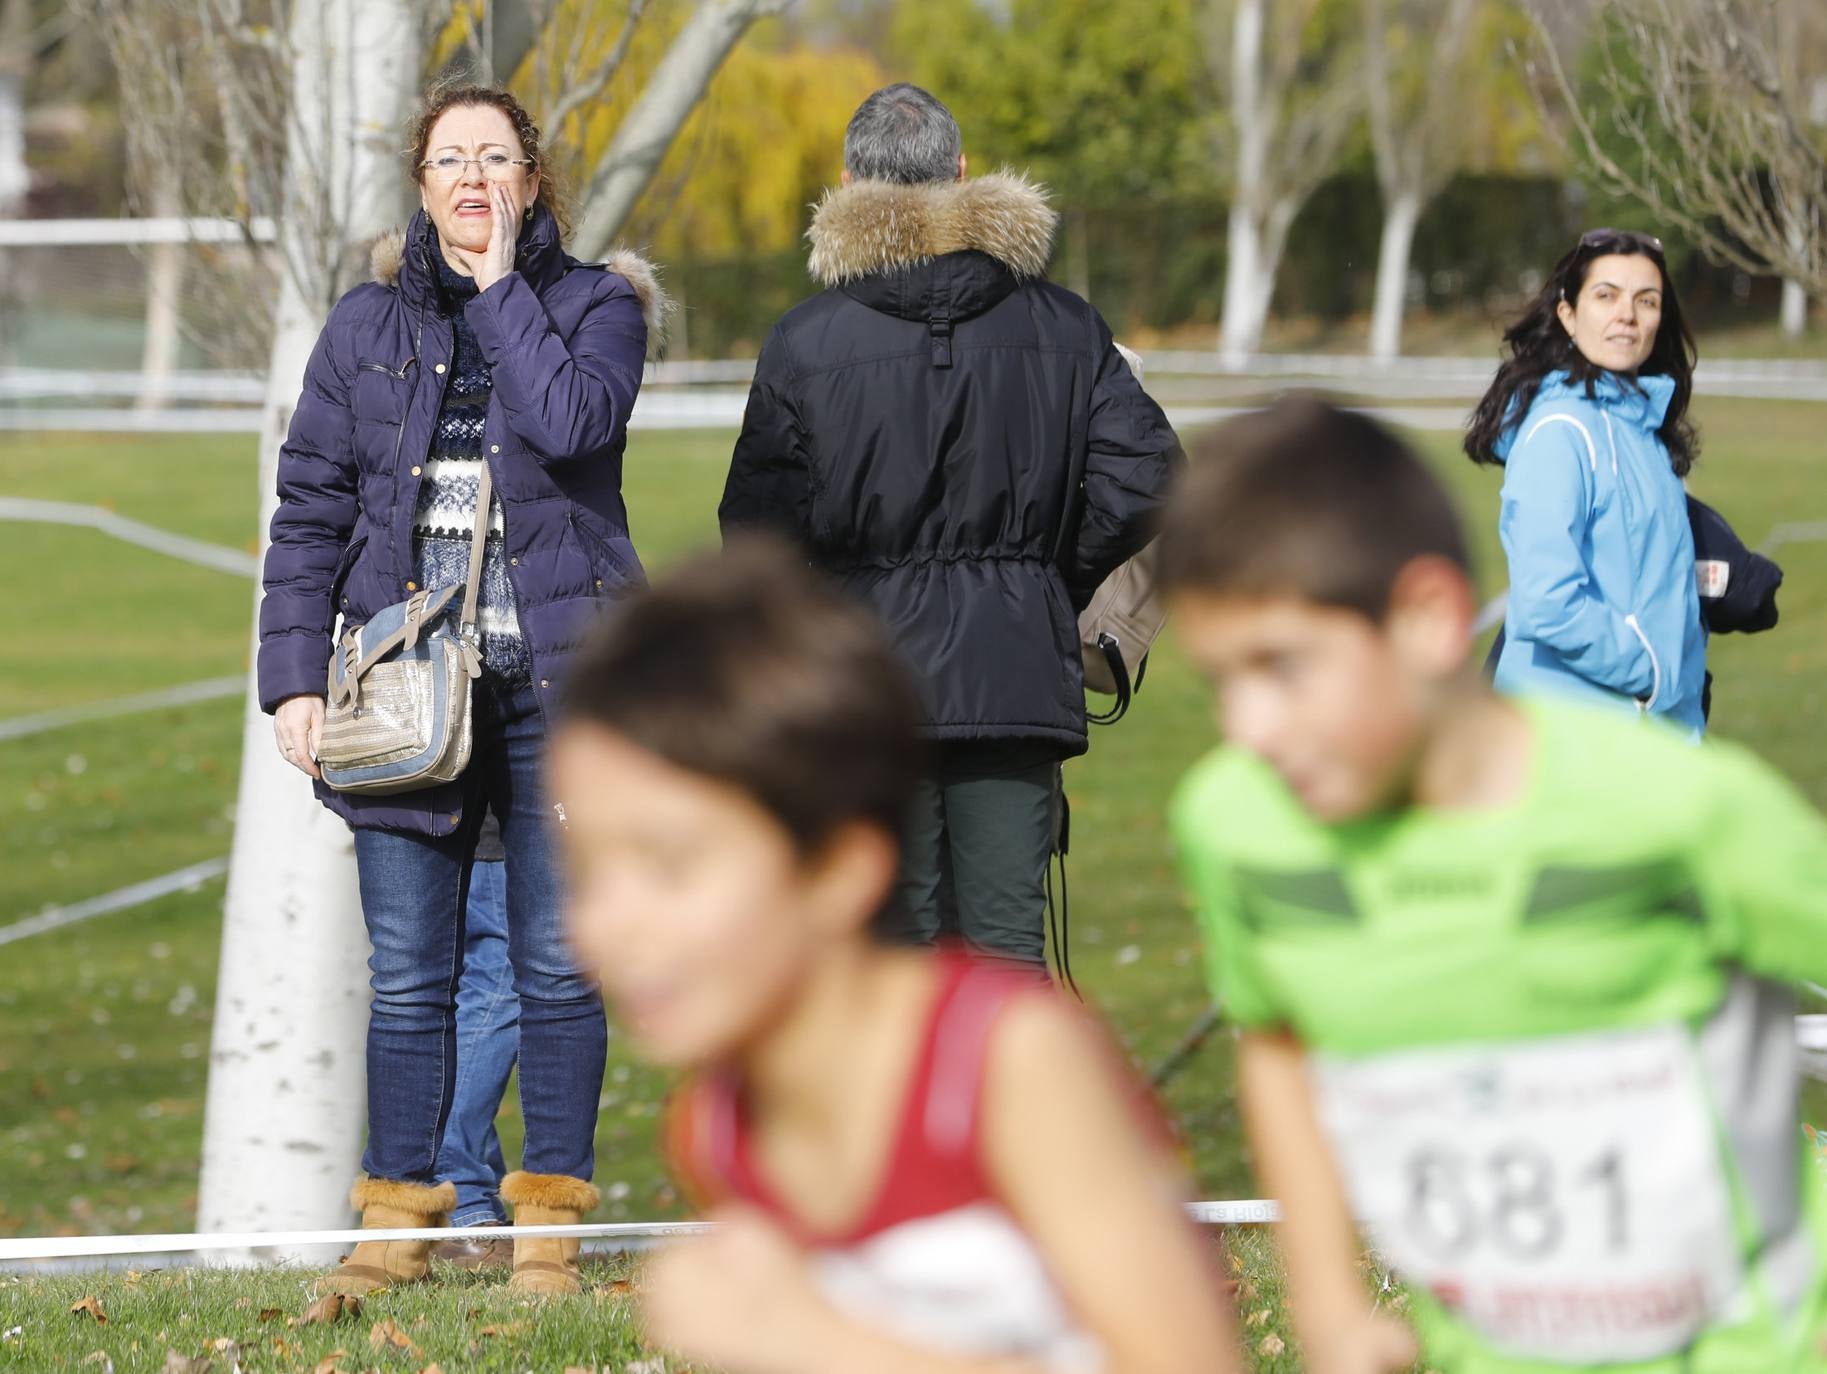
[{"x1": 259, "y1": 86, "x2": 665, "y2": 1292}]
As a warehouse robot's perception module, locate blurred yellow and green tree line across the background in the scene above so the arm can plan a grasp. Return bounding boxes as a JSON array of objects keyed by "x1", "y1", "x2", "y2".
[{"x1": 0, "y1": 0, "x2": 1827, "y2": 365}]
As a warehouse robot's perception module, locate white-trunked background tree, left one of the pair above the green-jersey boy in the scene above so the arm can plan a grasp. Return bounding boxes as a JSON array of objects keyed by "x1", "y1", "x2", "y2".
[{"x1": 1209, "y1": 0, "x2": 1363, "y2": 367}]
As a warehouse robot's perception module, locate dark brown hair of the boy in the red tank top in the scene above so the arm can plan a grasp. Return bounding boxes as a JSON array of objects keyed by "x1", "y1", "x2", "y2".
[{"x1": 565, "y1": 535, "x2": 923, "y2": 853}]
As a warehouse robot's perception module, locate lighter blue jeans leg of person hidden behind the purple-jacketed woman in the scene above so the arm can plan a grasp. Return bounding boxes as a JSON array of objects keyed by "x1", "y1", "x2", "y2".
[{"x1": 435, "y1": 859, "x2": 521, "y2": 1226}]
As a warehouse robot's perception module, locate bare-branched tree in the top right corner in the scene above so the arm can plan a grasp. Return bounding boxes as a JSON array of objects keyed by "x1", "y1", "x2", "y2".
[{"x1": 1533, "y1": 0, "x2": 1827, "y2": 294}]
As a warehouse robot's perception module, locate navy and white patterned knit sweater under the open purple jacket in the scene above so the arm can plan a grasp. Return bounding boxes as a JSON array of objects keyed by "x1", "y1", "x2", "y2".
[{"x1": 413, "y1": 252, "x2": 532, "y2": 683}]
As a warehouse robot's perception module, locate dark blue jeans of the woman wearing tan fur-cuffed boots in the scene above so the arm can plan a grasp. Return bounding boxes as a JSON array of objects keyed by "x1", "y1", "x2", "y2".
[{"x1": 354, "y1": 674, "x2": 608, "y2": 1184}]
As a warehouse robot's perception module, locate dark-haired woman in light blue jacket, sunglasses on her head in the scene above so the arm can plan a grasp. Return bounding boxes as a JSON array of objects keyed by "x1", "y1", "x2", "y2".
[{"x1": 1465, "y1": 228, "x2": 1706, "y2": 736}]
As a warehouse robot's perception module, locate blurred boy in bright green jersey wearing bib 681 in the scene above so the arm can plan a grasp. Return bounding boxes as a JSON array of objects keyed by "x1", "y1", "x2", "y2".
[{"x1": 1160, "y1": 400, "x2": 1827, "y2": 1374}]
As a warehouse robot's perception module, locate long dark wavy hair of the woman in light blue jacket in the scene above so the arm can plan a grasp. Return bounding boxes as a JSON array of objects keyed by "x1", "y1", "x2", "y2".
[{"x1": 1465, "y1": 228, "x2": 1701, "y2": 477}]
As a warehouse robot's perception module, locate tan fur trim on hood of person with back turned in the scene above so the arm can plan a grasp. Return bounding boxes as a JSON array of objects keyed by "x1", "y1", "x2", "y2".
[{"x1": 806, "y1": 172, "x2": 1060, "y2": 287}]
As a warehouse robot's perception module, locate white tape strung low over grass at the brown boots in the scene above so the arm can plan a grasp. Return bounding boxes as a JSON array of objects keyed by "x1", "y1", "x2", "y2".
[{"x1": 0, "y1": 1199, "x2": 1281, "y2": 1263}]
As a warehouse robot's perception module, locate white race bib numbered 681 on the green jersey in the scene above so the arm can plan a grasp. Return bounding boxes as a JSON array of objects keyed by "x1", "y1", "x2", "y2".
[{"x1": 1314, "y1": 1027, "x2": 1743, "y2": 1365}]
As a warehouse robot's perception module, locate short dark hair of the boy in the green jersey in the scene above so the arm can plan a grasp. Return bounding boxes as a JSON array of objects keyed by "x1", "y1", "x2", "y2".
[{"x1": 1158, "y1": 396, "x2": 1471, "y2": 619}]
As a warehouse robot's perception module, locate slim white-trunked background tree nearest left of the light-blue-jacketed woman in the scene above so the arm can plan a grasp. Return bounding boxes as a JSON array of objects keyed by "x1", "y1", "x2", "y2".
[{"x1": 1363, "y1": 0, "x2": 1478, "y2": 358}]
